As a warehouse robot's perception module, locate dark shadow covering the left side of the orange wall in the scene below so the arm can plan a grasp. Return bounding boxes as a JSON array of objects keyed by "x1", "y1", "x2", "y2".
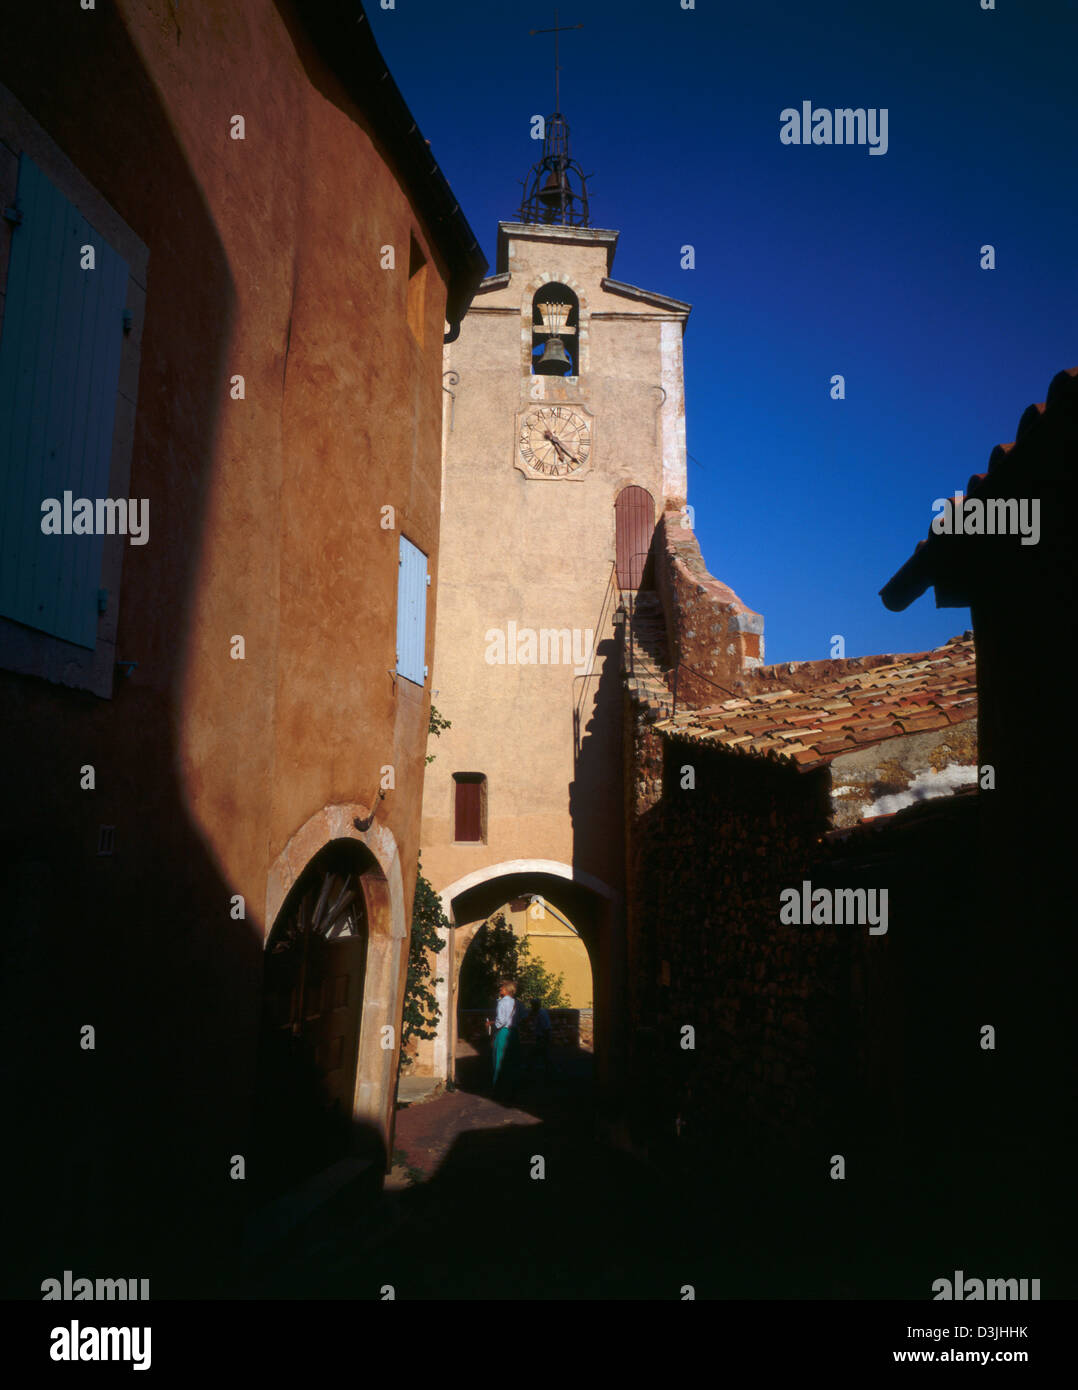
[{"x1": 0, "y1": 3, "x2": 269, "y2": 1297}]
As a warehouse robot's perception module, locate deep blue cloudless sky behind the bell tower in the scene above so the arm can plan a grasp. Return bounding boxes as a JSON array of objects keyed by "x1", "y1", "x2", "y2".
[{"x1": 367, "y1": 0, "x2": 1078, "y2": 662}]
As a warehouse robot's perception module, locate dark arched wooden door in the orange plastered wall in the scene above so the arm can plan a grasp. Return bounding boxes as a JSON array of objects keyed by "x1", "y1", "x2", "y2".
[{"x1": 250, "y1": 841, "x2": 374, "y2": 1197}]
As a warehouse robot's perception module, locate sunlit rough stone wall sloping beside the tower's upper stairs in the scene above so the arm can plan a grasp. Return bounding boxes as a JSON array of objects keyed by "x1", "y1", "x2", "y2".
[{"x1": 652, "y1": 512, "x2": 764, "y2": 705}]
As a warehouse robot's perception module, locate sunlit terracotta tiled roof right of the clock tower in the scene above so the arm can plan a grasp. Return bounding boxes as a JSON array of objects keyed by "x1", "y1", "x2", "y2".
[{"x1": 654, "y1": 634, "x2": 977, "y2": 771}]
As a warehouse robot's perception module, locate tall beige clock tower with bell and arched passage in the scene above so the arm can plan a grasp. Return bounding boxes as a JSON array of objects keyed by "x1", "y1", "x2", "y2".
[{"x1": 415, "y1": 105, "x2": 689, "y2": 1079}]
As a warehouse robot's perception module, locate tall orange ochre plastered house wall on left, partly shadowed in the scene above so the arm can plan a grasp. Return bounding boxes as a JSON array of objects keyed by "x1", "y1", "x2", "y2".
[{"x1": 0, "y1": 0, "x2": 446, "y2": 1273}]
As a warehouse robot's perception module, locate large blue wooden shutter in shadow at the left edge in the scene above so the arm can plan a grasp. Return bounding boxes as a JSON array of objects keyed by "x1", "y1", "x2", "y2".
[{"x1": 0, "y1": 154, "x2": 128, "y2": 649}]
